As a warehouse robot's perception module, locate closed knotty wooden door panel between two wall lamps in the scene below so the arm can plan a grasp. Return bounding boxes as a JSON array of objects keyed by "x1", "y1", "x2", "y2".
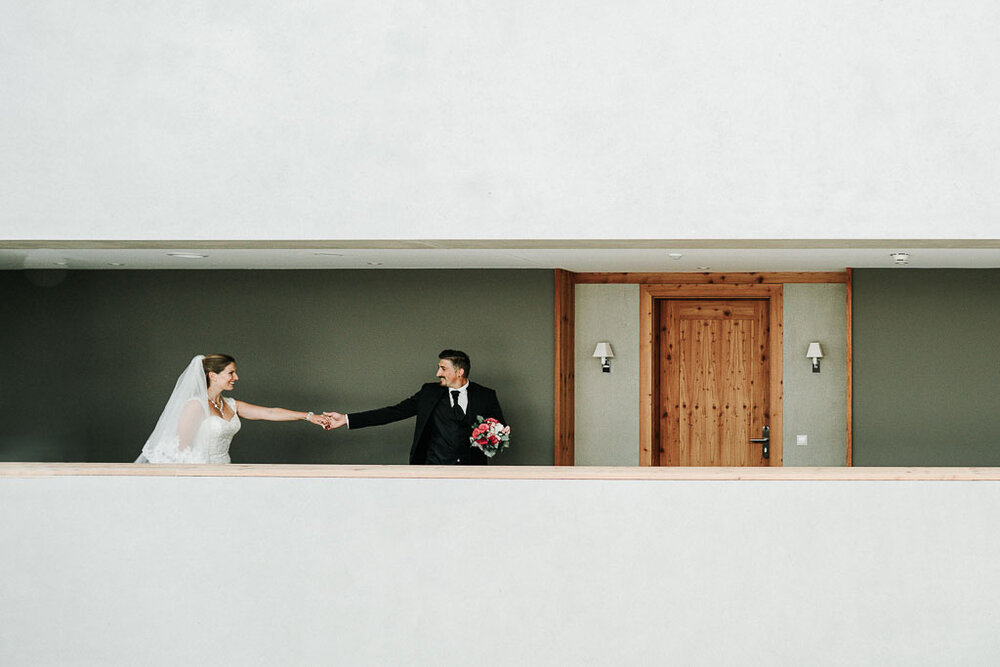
[{"x1": 656, "y1": 299, "x2": 768, "y2": 466}]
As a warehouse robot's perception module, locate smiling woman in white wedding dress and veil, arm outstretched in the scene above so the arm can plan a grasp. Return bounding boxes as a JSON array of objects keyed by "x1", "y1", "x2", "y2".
[{"x1": 135, "y1": 354, "x2": 326, "y2": 463}]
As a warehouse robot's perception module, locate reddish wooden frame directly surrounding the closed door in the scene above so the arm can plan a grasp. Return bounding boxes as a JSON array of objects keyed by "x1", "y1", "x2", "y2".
[{"x1": 639, "y1": 283, "x2": 784, "y2": 466}]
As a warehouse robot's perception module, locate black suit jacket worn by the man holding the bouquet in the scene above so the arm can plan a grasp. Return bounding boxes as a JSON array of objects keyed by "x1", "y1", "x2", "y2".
[{"x1": 347, "y1": 382, "x2": 507, "y2": 465}]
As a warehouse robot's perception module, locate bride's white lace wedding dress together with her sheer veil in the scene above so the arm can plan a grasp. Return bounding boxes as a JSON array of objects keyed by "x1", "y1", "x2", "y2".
[{"x1": 136, "y1": 355, "x2": 240, "y2": 463}]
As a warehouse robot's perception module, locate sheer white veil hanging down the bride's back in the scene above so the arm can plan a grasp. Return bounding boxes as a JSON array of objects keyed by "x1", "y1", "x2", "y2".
[{"x1": 135, "y1": 354, "x2": 209, "y2": 463}]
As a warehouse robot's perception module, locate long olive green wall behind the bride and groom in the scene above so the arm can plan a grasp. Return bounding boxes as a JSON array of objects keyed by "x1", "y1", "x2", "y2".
[{"x1": 0, "y1": 270, "x2": 553, "y2": 465}]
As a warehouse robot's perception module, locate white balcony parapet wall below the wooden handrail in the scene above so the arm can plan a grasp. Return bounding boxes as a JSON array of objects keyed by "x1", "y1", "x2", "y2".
[{"x1": 0, "y1": 477, "x2": 1000, "y2": 667}]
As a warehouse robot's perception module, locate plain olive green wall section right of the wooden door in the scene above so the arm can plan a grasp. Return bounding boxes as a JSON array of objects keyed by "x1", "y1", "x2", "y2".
[{"x1": 854, "y1": 269, "x2": 1000, "y2": 466}]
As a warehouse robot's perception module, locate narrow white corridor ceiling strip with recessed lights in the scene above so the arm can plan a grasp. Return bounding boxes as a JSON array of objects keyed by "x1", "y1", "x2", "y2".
[{"x1": 0, "y1": 240, "x2": 1000, "y2": 272}]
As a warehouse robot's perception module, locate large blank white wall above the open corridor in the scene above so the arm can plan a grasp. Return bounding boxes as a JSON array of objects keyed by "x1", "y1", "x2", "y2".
[{"x1": 0, "y1": 0, "x2": 1000, "y2": 240}]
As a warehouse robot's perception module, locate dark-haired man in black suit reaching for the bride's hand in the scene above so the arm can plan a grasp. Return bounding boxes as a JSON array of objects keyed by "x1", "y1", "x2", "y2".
[{"x1": 323, "y1": 350, "x2": 507, "y2": 465}]
